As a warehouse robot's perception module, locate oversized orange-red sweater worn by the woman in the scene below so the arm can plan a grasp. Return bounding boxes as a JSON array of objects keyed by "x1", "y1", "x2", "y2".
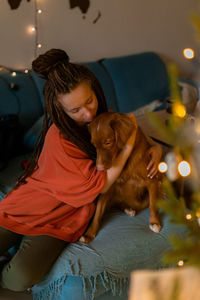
[{"x1": 0, "y1": 124, "x2": 106, "y2": 242}]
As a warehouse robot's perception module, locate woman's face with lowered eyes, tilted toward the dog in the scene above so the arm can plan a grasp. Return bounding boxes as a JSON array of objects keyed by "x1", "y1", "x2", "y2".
[{"x1": 58, "y1": 81, "x2": 98, "y2": 125}]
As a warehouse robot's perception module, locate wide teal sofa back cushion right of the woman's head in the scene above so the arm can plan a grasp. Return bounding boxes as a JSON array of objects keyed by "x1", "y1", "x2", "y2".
[{"x1": 102, "y1": 52, "x2": 169, "y2": 113}]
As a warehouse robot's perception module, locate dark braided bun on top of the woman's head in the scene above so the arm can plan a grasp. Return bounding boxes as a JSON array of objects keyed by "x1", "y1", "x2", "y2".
[{"x1": 32, "y1": 49, "x2": 69, "y2": 79}]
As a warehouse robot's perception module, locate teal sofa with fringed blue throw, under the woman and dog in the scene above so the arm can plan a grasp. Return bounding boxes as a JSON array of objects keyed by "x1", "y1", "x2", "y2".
[{"x1": 0, "y1": 52, "x2": 188, "y2": 300}]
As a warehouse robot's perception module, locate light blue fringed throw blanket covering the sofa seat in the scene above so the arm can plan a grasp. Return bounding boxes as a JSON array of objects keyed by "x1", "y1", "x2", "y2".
[{"x1": 33, "y1": 209, "x2": 185, "y2": 300}]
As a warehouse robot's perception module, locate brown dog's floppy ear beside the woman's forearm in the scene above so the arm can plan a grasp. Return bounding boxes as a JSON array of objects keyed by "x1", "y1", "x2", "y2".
[{"x1": 110, "y1": 113, "x2": 138, "y2": 149}]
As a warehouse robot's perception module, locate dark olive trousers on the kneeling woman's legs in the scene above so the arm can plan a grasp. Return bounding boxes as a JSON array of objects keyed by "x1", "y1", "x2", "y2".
[{"x1": 0, "y1": 227, "x2": 67, "y2": 291}]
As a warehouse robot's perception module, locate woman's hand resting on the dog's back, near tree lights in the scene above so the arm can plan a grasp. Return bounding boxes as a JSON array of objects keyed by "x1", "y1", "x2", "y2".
[{"x1": 147, "y1": 144, "x2": 162, "y2": 179}]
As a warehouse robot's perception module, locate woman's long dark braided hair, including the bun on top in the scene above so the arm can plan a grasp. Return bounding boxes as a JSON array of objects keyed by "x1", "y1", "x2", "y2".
[{"x1": 14, "y1": 49, "x2": 108, "y2": 189}]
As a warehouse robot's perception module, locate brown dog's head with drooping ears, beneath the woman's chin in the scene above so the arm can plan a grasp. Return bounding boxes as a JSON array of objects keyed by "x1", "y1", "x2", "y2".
[{"x1": 89, "y1": 112, "x2": 137, "y2": 170}]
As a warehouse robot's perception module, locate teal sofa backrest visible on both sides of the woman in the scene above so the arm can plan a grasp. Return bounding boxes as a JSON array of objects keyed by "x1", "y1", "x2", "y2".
[{"x1": 0, "y1": 52, "x2": 169, "y2": 149}]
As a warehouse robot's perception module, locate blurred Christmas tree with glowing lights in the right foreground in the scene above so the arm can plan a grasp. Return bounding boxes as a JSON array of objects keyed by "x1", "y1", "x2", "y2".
[{"x1": 148, "y1": 11, "x2": 200, "y2": 268}]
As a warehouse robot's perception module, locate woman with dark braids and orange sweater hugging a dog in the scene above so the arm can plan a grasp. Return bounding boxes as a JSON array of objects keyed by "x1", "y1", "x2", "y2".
[{"x1": 0, "y1": 49, "x2": 162, "y2": 291}]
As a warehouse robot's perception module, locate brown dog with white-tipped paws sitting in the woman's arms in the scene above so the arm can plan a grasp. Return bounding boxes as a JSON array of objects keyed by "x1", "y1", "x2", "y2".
[{"x1": 80, "y1": 112, "x2": 161, "y2": 243}]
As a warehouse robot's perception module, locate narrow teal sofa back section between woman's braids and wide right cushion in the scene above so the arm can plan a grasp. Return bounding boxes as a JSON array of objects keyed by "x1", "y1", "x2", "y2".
[{"x1": 85, "y1": 62, "x2": 119, "y2": 111}]
